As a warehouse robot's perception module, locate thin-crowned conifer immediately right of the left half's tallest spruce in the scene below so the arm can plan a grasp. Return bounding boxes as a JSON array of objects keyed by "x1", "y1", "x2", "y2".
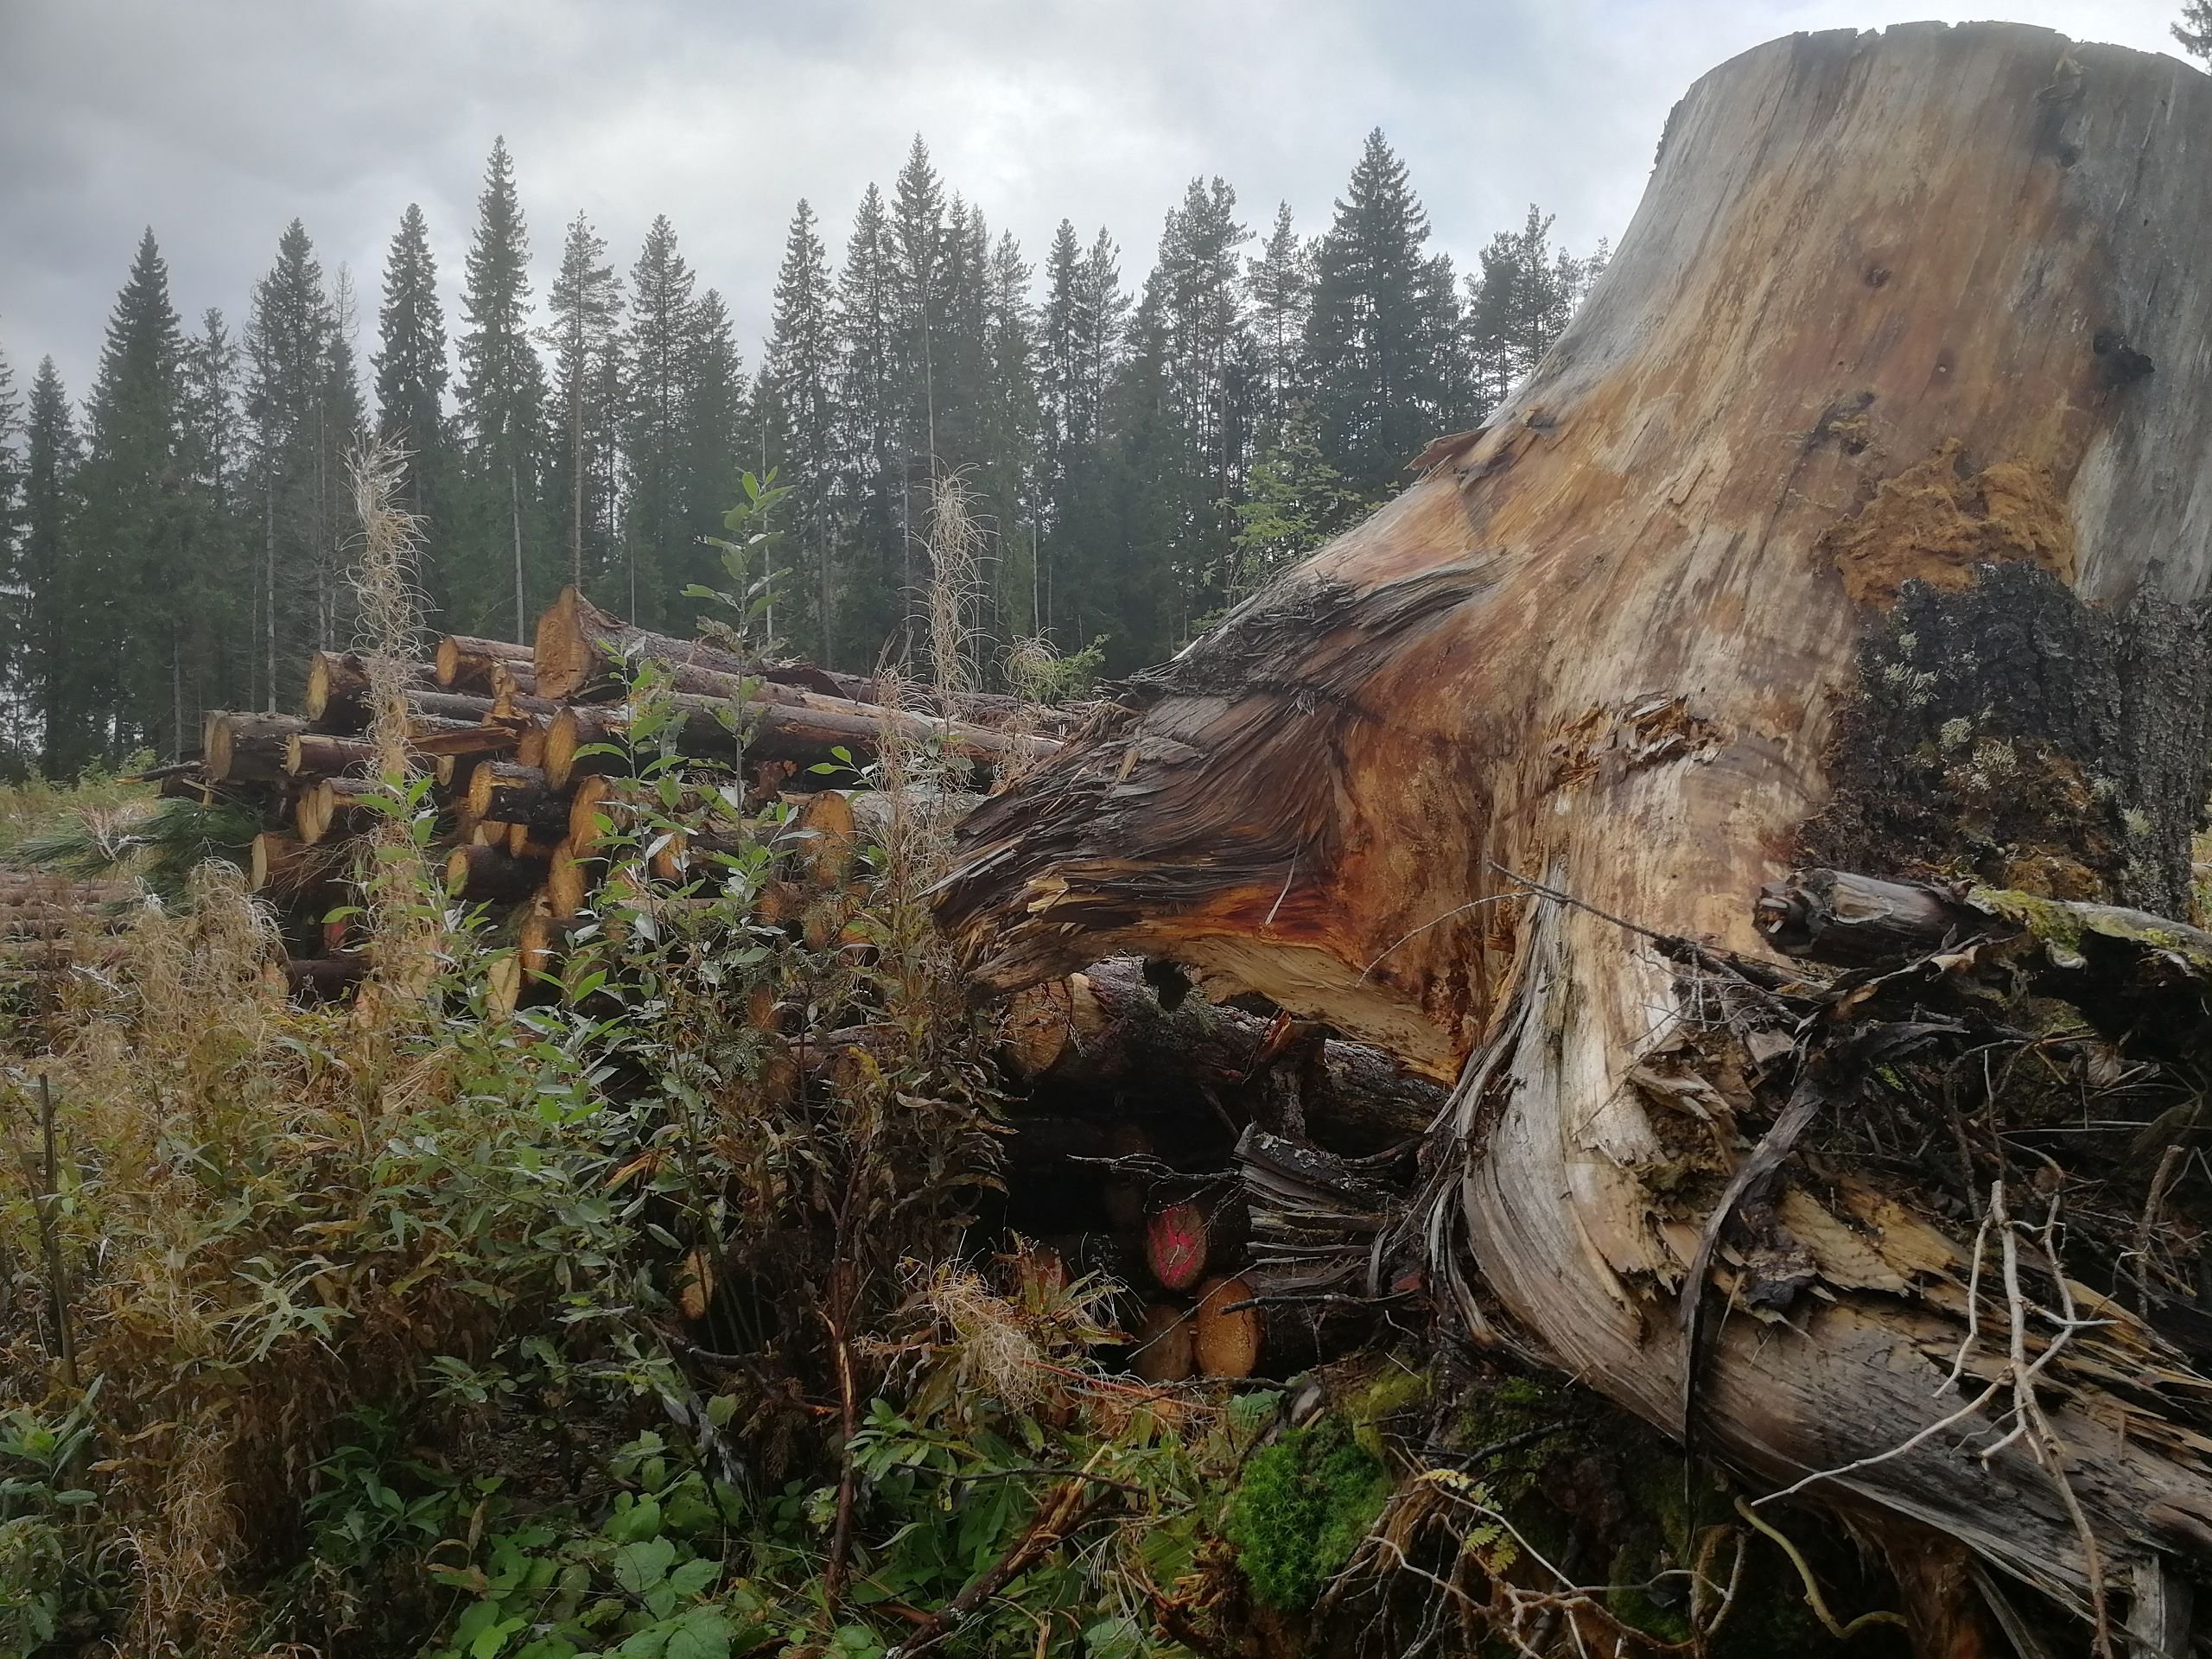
[{"x1": 546, "y1": 213, "x2": 621, "y2": 588}]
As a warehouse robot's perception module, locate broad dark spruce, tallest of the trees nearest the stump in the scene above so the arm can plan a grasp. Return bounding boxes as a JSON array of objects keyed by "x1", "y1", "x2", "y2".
[{"x1": 1305, "y1": 128, "x2": 1469, "y2": 500}]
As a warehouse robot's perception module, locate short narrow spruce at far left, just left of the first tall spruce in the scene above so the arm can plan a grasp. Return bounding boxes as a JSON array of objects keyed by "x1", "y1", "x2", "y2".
[{"x1": 16, "y1": 356, "x2": 84, "y2": 777}]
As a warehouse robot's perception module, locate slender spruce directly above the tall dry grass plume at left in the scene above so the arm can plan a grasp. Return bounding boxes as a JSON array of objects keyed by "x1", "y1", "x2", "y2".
[{"x1": 372, "y1": 201, "x2": 455, "y2": 617}]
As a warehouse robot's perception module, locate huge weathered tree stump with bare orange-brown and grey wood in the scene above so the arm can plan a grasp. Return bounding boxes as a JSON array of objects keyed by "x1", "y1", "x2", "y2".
[{"x1": 940, "y1": 24, "x2": 2212, "y2": 1645}]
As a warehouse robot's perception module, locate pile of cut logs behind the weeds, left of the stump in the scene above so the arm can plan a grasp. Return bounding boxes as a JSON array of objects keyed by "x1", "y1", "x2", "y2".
[{"x1": 162, "y1": 588, "x2": 1077, "y2": 1007}]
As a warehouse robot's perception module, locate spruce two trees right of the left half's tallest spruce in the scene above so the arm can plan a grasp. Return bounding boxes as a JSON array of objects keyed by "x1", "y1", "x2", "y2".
[{"x1": 621, "y1": 214, "x2": 695, "y2": 626}]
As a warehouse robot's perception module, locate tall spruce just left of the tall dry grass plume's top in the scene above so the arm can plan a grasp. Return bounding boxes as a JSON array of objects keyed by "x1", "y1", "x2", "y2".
[{"x1": 245, "y1": 219, "x2": 336, "y2": 708}]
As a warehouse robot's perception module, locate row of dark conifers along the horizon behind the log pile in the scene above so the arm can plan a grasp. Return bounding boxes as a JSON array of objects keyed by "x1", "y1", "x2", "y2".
[{"x1": 0, "y1": 130, "x2": 1604, "y2": 772}]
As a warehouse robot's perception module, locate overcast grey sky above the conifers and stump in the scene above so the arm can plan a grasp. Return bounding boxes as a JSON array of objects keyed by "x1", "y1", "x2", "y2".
[{"x1": 0, "y1": 0, "x2": 2181, "y2": 398}]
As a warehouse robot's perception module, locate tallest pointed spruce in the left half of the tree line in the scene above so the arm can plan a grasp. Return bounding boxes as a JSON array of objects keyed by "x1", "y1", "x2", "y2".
[{"x1": 454, "y1": 137, "x2": 549, "y2": 639}]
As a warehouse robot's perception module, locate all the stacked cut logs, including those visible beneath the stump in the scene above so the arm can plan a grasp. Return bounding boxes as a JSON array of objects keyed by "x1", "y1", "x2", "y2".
[{"x1": 125, "y1": 591, "x2": 1442, "y2": 1382}]
